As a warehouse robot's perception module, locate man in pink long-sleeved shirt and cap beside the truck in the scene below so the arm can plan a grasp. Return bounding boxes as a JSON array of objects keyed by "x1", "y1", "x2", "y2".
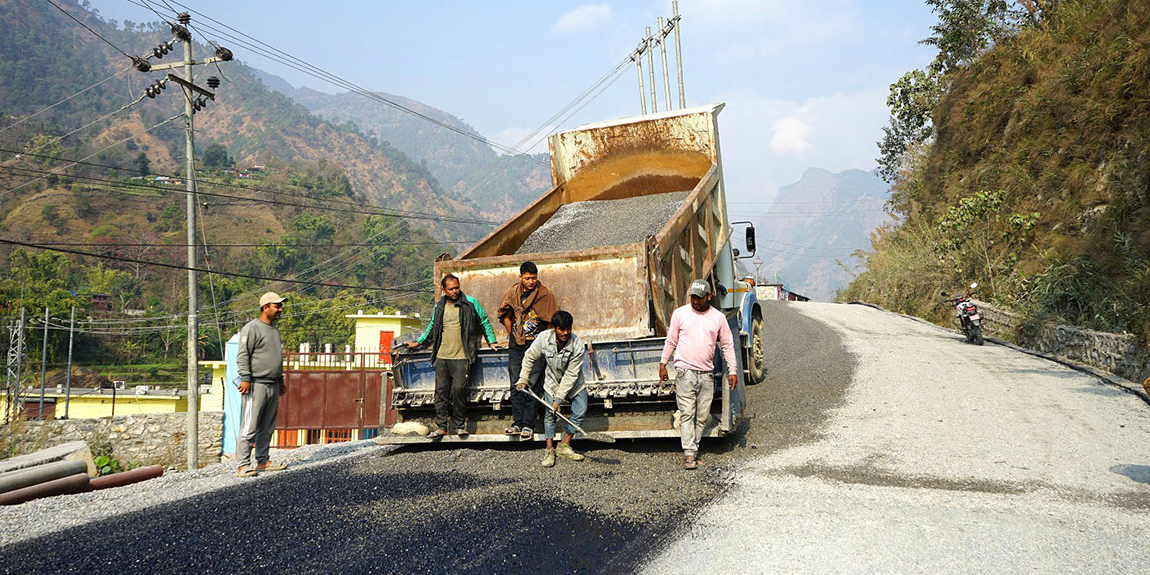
[{"x1": 659, "y1": 279, "x2": 738, "y2": 469}]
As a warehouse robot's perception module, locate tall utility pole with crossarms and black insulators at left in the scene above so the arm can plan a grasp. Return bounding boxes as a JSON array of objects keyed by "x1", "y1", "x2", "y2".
[{"x1": 143, "y1": 12, "x2": 232, "y2": 469}]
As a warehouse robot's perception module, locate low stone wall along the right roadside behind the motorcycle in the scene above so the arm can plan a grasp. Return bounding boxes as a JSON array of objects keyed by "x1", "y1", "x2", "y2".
[{"x1": 975, "y1": 301, "x2": 1150, "y2": 383}]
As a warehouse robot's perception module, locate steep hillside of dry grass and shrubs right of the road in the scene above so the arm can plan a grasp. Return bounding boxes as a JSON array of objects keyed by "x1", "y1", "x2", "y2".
[{"x1": 843, "y1": 0, "x2": 1150, "y2": 336}]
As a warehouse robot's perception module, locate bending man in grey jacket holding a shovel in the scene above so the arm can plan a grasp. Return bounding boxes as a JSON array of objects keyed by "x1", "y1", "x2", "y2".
[{"x1": 524, "y1": 311, "x2": 587, "y2": 467}]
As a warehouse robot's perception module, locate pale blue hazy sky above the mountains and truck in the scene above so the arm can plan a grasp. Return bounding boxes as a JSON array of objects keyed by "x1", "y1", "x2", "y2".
[{"x1": 92, "y1": 0, "x2": 935, "y2": 211}]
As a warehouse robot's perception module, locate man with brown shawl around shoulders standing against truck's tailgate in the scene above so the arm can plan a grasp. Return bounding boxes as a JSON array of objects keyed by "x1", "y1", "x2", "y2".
[{"x1": 498, "y1": 261, "x2": 559, "y2": 439}]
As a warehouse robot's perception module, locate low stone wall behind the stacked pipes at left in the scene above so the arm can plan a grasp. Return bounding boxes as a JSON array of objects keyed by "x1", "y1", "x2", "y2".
[{"x1": 6, "y1": 412, "x2": 223, "y2": 468}]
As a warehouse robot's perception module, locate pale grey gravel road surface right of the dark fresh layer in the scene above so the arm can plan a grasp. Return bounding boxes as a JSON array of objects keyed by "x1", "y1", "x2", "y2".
[{"x1": 645, "y1": 304, "x2": 1150, "y2": 573}]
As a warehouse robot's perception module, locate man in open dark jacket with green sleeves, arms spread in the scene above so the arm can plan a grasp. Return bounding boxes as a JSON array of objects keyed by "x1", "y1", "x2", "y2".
[{"x1": 407, "y1": 274, "x2": 499, "y2": 439}]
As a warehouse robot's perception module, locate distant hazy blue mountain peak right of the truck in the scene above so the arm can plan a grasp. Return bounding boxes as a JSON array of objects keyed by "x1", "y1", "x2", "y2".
[{"x1": 756, "y1": 168, "x2": 890, "y2": 301}]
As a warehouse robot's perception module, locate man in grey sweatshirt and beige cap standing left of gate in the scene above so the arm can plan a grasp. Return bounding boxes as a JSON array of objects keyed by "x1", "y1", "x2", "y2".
[{"x1": 236, "y1": 292, "x2": 288, "y2": 477}]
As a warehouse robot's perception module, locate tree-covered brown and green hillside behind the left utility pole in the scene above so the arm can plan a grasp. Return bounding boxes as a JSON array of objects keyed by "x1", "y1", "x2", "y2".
[{"x1": 0, "y1": 0, "x2": 457, "y2": 365}]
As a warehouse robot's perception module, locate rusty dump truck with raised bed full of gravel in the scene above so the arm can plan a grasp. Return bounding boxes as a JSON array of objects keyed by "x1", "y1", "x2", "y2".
[{"x1": 377, "y1": 104, "x2": 765, "y2": 444}]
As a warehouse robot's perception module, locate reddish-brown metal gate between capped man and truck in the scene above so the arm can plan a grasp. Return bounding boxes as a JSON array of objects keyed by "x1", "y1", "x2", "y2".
[{"x1": 276, "y1": 352, "x2": 391, "y2": 447}]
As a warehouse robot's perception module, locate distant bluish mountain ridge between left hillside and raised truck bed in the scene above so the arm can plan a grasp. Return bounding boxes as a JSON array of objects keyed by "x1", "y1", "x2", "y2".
[{"x1": 260, "y1": 72, "x2": 551, "y2": 220}]
